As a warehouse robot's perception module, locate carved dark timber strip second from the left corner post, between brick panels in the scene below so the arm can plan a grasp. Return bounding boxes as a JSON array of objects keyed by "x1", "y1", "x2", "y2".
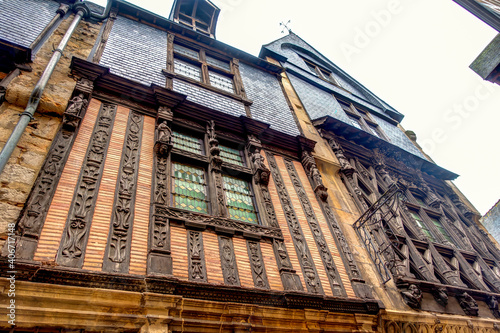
[{"x1": 102, "y1": 112, "x2": 144, "y2": 273}]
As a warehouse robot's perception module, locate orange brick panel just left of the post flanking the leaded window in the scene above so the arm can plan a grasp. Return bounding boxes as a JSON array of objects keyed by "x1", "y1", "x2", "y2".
[{"x1": 129, "y1": 117, "x2": 155, "y2": 275}]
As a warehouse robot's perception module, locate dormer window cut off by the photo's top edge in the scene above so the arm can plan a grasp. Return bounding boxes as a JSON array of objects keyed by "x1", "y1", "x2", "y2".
[{"x1": 170, "y1": 0, "x2": 220, "y2": 38}]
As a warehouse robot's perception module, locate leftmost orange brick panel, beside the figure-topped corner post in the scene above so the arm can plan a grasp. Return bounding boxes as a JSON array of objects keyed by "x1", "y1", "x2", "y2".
[{"x1": 34, "y1": 99, "x2": 101, "y2": 261}]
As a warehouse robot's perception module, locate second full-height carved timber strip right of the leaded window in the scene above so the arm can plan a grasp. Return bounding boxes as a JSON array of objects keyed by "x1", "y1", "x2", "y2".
[{"x1": 285, "y1": 159, "x2": 347, "y2": 296}]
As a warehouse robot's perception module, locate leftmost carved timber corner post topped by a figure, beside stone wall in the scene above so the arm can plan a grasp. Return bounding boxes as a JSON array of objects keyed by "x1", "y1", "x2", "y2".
[{"x1": 16, "y1": 78, "x2": 94, "y2": 260}]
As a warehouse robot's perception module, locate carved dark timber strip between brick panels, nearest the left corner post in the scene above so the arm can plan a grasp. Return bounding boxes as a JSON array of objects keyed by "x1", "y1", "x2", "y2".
[{"x1": 56, "y1": 104, "x2": 116, "y2": 268}]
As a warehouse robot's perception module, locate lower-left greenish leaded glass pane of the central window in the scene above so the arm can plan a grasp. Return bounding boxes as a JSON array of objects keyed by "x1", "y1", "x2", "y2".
[{"x1": 172, "y1": 162, "x2": 208, "y2": 213}]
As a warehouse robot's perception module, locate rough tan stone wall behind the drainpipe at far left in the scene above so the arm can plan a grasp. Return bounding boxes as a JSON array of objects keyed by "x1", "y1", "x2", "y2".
[{"x1": 0, "y1": 13, "x2": 100, "y2": 236}]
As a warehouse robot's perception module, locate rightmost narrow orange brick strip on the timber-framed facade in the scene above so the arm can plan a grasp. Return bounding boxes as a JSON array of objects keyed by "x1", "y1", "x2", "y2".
[{"x1": 293, "y1": 161, "x2": 356, "y2": 297}]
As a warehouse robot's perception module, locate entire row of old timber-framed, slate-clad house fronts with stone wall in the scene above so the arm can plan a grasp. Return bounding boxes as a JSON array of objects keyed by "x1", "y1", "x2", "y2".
[{"x1": 0, "y1": 0, "x2": 500, "y2": 333}]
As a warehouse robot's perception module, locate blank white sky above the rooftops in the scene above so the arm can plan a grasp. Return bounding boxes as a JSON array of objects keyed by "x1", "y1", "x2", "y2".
[{"x1": 94, "y1": 0, "x2": 500, "y2": 214}]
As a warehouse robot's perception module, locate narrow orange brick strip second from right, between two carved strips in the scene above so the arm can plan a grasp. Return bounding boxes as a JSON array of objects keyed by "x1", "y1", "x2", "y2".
[{"x1": 275, "y1": 156, "x2": 333, "y2": 296}]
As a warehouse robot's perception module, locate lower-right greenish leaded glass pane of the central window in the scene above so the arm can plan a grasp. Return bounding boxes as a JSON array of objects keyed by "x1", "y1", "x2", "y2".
[{"x1": 223, "y1": 175, "x2": 258, "y2": 223}]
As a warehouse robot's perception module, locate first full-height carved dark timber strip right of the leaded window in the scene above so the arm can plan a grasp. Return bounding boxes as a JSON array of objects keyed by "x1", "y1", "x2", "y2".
[{"x1": 267, "y1": 154, "x2": 324, "y2": 294}]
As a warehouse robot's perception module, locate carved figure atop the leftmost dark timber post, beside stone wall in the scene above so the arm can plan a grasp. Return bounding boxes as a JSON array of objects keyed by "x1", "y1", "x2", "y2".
[{"x1": 63, "y1": 78, "x2": 94, "y2": 131}]
